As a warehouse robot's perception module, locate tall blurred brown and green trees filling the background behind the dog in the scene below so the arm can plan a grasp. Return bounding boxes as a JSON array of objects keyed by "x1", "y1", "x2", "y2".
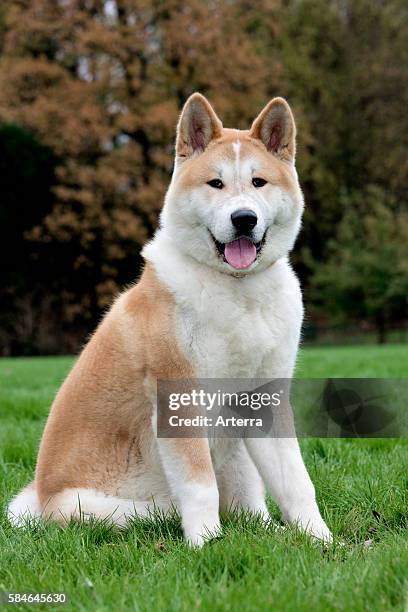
[{"x1": 0, "y1": 0, "x2": 408, "y2": 351}]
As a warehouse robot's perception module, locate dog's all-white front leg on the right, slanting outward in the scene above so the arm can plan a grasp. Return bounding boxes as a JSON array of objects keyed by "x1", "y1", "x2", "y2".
[{"x1": 246, "y1": 437, "x2": 332, "y2": 542}]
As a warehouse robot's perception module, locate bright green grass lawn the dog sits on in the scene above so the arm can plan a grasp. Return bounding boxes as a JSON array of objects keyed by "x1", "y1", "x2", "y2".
[{"x1": 0, "y1": 345, "x2": 408, "y2": 611}]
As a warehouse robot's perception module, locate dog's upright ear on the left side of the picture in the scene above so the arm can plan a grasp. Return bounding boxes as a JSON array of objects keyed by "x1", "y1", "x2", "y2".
[{"x1": 176, "y1": 93, "x2": 222, "y2": 158}]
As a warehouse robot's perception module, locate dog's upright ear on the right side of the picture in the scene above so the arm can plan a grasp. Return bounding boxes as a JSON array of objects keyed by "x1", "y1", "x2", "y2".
[{"x1": 249, "y1": 98, "x2": 296, "y2": 162}]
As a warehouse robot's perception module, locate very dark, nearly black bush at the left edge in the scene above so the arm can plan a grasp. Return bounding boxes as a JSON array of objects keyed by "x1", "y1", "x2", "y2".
[{"x1": 0, "y1": 124, "x2": 57, "y2": 354}]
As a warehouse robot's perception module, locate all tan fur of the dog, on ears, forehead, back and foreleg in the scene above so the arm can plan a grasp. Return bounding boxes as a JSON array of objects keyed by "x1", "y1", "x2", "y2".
[{"x1": 36, "y1": 94, "x2": 296, "y2": 514}]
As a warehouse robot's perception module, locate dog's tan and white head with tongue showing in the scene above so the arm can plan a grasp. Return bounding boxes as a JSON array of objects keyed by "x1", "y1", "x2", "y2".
[{"x1": 162, "y1": 93, "x2": 303, "y2": 276}]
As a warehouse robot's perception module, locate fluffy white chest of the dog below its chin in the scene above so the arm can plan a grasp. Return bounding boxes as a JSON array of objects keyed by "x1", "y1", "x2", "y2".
[{"x1": 177, "y1": 258, "x2": 302, "y2": 378}]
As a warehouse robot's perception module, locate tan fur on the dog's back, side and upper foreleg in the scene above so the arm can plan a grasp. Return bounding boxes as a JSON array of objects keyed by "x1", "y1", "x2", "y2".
[{"x1": 36, "y1": 264, "x2": 207, "y2": 518}]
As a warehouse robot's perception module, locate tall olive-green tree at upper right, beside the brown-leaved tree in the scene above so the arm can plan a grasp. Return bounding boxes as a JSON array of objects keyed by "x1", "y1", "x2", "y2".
[{"x1": 278, "y1": 0, "x2": 408, "y2": 276}]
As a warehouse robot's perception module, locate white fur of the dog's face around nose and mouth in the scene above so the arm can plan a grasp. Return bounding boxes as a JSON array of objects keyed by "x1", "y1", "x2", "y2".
[{"x1": 161, "y1": 143, "x2": 304, "y2": 276}]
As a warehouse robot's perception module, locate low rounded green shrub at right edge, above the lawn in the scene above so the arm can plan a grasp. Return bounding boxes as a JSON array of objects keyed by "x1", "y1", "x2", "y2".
[{"x1": 313, "y1": 188, "x2": 408, "y2": 343}]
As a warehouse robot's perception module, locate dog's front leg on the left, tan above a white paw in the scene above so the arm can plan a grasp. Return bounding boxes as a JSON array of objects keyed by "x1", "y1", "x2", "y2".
[{"x1": 158, "y1": 438, "x2": 220, "y2": 546}]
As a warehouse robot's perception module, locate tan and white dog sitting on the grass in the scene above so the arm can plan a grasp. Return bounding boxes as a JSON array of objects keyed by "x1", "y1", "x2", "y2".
[{"x1": 8, "y1": 93, "x2": 332, "y2": 546}]
